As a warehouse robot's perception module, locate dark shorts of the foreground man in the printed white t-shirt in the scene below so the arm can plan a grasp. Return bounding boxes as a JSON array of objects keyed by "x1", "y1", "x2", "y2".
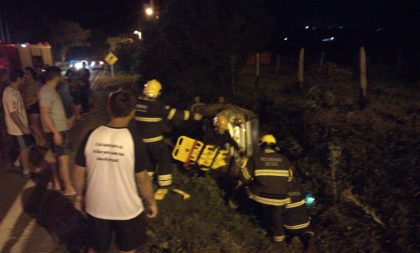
[{"x1": 88, "y1": 212, "x2": 147, "y2": 252}]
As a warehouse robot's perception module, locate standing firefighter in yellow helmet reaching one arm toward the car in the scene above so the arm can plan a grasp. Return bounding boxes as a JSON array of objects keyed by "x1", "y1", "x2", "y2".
[{"x1": 135, "y1": 79, "x2": 202, "y2": 200}]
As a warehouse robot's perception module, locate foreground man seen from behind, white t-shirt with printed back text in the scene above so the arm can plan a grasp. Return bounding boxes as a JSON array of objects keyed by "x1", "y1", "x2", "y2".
[{"x1": 74, "y1": 90, "x2": 158, "y2": 252}]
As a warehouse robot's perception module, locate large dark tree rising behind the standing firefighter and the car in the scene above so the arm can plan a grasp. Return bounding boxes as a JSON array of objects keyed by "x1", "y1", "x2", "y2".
[{"x1": 136, "y1": 0, "x2": 271, "y2": 101}]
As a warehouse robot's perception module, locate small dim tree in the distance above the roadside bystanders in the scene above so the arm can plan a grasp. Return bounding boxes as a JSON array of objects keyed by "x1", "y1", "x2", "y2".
[{"x1": 51, "y1": 21, "x2": 91, "y2": 62}]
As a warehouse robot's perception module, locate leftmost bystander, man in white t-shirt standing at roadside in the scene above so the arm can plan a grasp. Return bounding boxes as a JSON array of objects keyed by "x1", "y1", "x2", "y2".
[{"x1": 2, "y1": 70, "x2": 33, "y2": 177}]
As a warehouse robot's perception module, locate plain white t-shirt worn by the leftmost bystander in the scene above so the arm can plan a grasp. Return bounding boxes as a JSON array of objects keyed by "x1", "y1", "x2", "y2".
[{"x1": 2, "y1": 86, "x2": 29, "y2": 135}]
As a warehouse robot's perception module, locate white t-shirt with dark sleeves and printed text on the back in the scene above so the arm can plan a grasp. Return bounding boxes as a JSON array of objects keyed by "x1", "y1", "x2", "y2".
[{"x1": 76, "y1": 126, "x2": 151, "y2": 220}]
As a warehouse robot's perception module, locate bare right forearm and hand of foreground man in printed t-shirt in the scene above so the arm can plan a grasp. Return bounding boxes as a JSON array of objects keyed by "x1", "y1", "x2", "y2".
[{"x1": 136, "y1": 170, "x2": 158, "y2": 218}]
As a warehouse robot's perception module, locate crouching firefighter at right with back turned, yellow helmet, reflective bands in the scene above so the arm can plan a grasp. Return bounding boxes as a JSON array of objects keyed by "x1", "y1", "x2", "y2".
[{"x1": 229, "y1": 135, "x2": 313, "y2": 247}]
